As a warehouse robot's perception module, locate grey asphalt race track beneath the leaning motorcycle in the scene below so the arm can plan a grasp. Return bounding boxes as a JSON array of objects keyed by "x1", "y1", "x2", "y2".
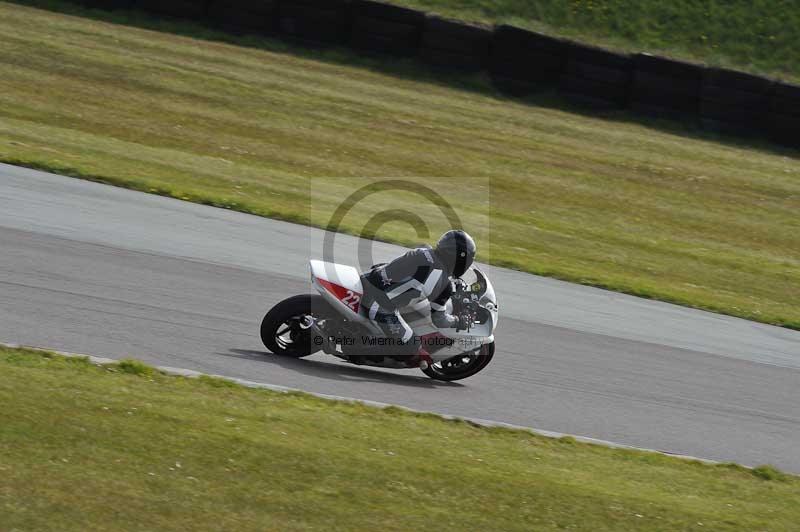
[{"x1": 0, "y1": 165, "x2": 800, "y2": 472}]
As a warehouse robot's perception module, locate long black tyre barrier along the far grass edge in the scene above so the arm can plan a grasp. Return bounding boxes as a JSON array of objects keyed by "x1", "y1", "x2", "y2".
[{"x1": 67, "y1": 0, "x2": 800, "y2": 147}]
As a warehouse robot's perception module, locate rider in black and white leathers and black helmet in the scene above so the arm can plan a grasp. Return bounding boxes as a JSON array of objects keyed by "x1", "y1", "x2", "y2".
[{"x1": 361, "y1": 230, "x2": 476, "y2": 363}]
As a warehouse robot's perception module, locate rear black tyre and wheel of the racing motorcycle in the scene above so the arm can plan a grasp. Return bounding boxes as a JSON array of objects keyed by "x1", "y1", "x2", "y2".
[{"x1": 261, "y1": 294, "x2": 329, "y2": 358}]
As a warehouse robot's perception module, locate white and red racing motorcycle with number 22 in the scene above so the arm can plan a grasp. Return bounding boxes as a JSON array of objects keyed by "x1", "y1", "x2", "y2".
[{"x1": 261, "y1": 260, "x2": 498, "y2": 381}]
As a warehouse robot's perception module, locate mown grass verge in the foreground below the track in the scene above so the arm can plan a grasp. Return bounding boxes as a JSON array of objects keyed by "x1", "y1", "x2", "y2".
[{"x1": 0, "y1": 347, "x2": 800, "y2": 532}]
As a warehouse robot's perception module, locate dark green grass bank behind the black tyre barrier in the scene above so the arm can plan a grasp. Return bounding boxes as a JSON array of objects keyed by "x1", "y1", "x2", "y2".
[{"x1": 391, "y1": 0, "x2": 800, "y2": 81}]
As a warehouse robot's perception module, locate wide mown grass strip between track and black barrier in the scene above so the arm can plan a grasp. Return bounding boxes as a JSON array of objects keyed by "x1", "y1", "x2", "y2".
[{"x1": 0, "y1": 2, "x2": 800, "y2": 328}]
